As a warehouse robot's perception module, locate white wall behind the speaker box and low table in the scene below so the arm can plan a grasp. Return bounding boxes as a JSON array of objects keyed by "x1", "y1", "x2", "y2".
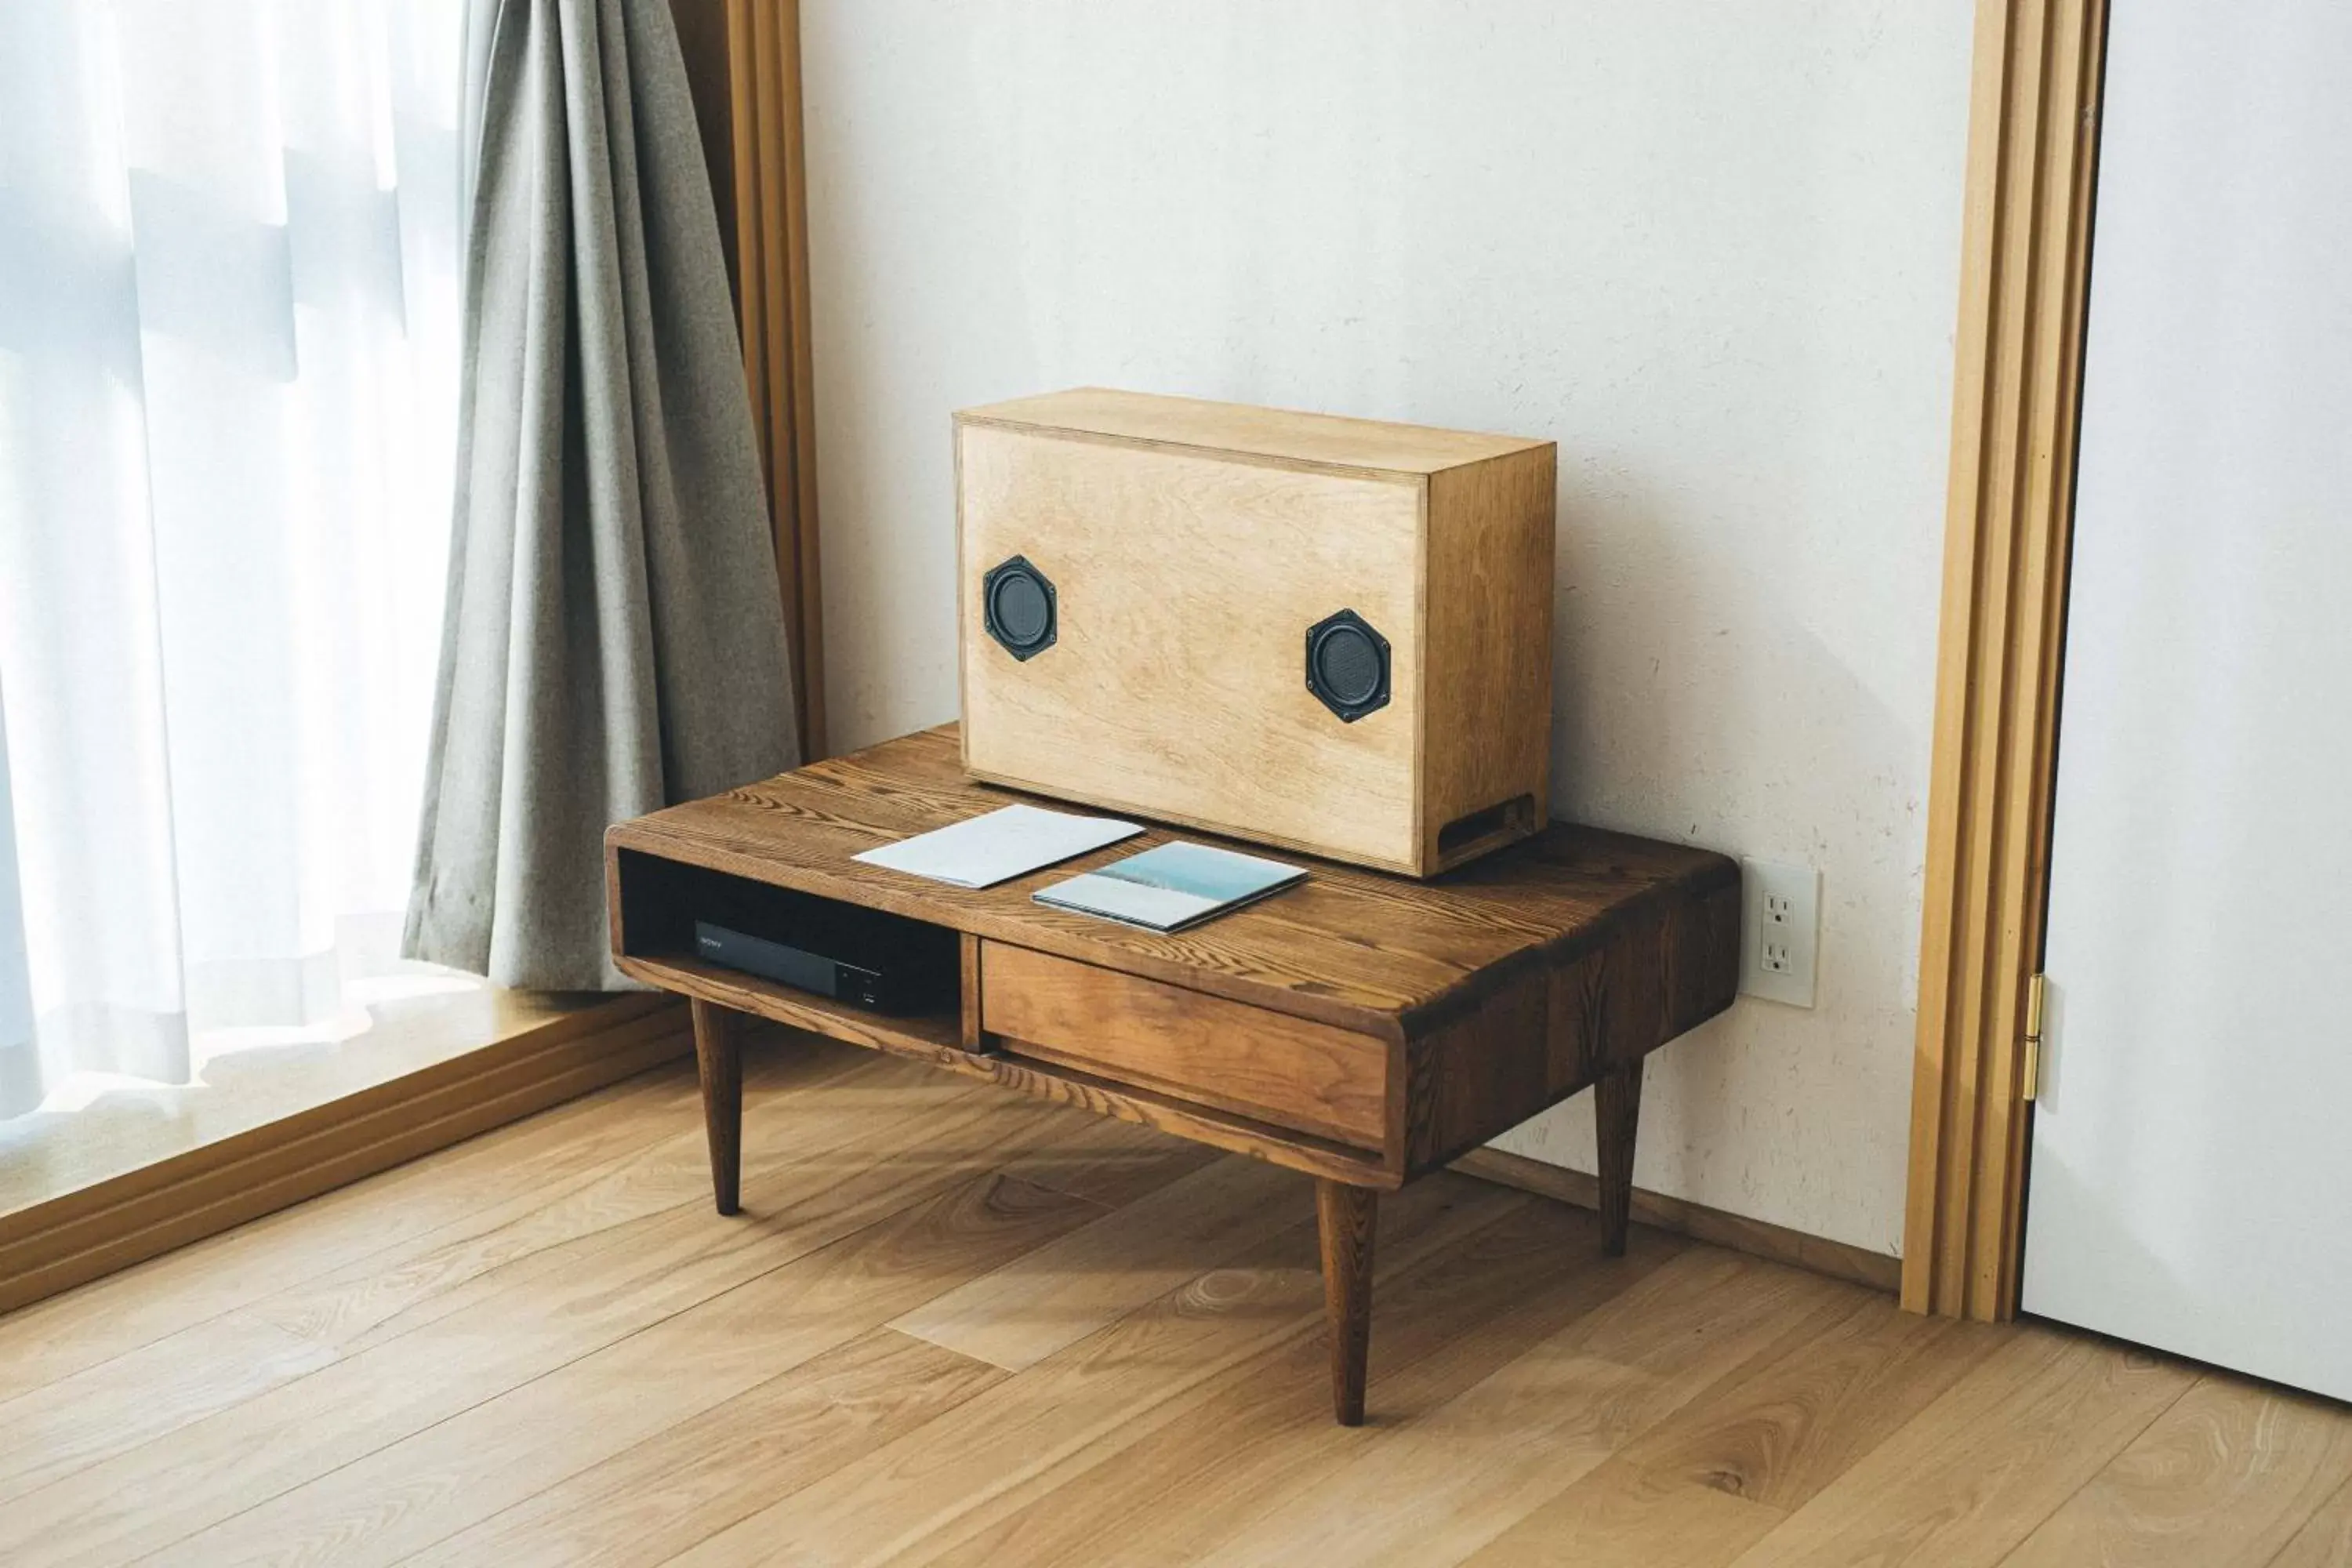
[{"x1": 804, "y1": 0, "x2": 1971, "y2": 1250}]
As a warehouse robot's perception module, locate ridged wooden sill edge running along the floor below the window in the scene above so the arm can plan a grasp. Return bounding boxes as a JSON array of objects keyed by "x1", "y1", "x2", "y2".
[{"x1": 0, "y1": 994, "x2": 694, "y2": 1312}]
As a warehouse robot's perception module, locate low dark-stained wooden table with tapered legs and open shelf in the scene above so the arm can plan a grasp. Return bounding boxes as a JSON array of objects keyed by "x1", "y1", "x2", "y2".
[{"x1": 604, "y1": 727, "x2": 1740, "y2": 1425}]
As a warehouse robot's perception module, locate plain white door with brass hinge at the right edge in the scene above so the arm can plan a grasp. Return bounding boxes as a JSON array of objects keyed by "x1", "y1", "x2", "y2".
[{"x1": 2025, "y1": 0, "x2": 2352, "y2": 1399}]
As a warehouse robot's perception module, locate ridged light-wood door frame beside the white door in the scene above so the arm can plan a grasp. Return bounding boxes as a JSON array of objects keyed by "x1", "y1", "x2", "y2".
[{"x1": 1903, "y1": 0, "x2": 2107, "y2": 1319}]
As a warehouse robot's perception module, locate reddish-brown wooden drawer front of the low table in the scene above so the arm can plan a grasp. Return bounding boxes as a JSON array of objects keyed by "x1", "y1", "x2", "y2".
[{"x1": 981, "y1": 942, "x2": 1388, "y2": 1149}]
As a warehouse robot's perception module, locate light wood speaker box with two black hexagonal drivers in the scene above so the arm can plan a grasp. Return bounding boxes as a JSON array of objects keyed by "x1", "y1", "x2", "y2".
[{"x1": 955, "y1": 388, "x2": 1555, "y2": 877}]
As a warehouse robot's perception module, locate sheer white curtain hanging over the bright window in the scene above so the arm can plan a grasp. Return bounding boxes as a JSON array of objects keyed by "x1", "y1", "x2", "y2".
[{"x1": 0, "y1": 0, "x2": 463, "y2": 1116}]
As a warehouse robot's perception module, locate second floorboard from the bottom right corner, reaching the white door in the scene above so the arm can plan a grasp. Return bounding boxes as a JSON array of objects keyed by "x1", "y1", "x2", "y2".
[{"x1": 2004, "y1": 1377, "x2": 2352, "y2": 1568}]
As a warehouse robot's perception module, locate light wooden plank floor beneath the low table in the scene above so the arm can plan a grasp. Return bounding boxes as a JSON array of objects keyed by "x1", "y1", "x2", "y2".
[{"x1": 0, "y1": 1041, "x2": 2352, "y2": 1568}]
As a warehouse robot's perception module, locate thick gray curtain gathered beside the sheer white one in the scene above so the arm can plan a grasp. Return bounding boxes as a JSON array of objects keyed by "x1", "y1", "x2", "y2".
[{"x1": 405, "y1": 0, "x2": 797, "y2": 989}]
